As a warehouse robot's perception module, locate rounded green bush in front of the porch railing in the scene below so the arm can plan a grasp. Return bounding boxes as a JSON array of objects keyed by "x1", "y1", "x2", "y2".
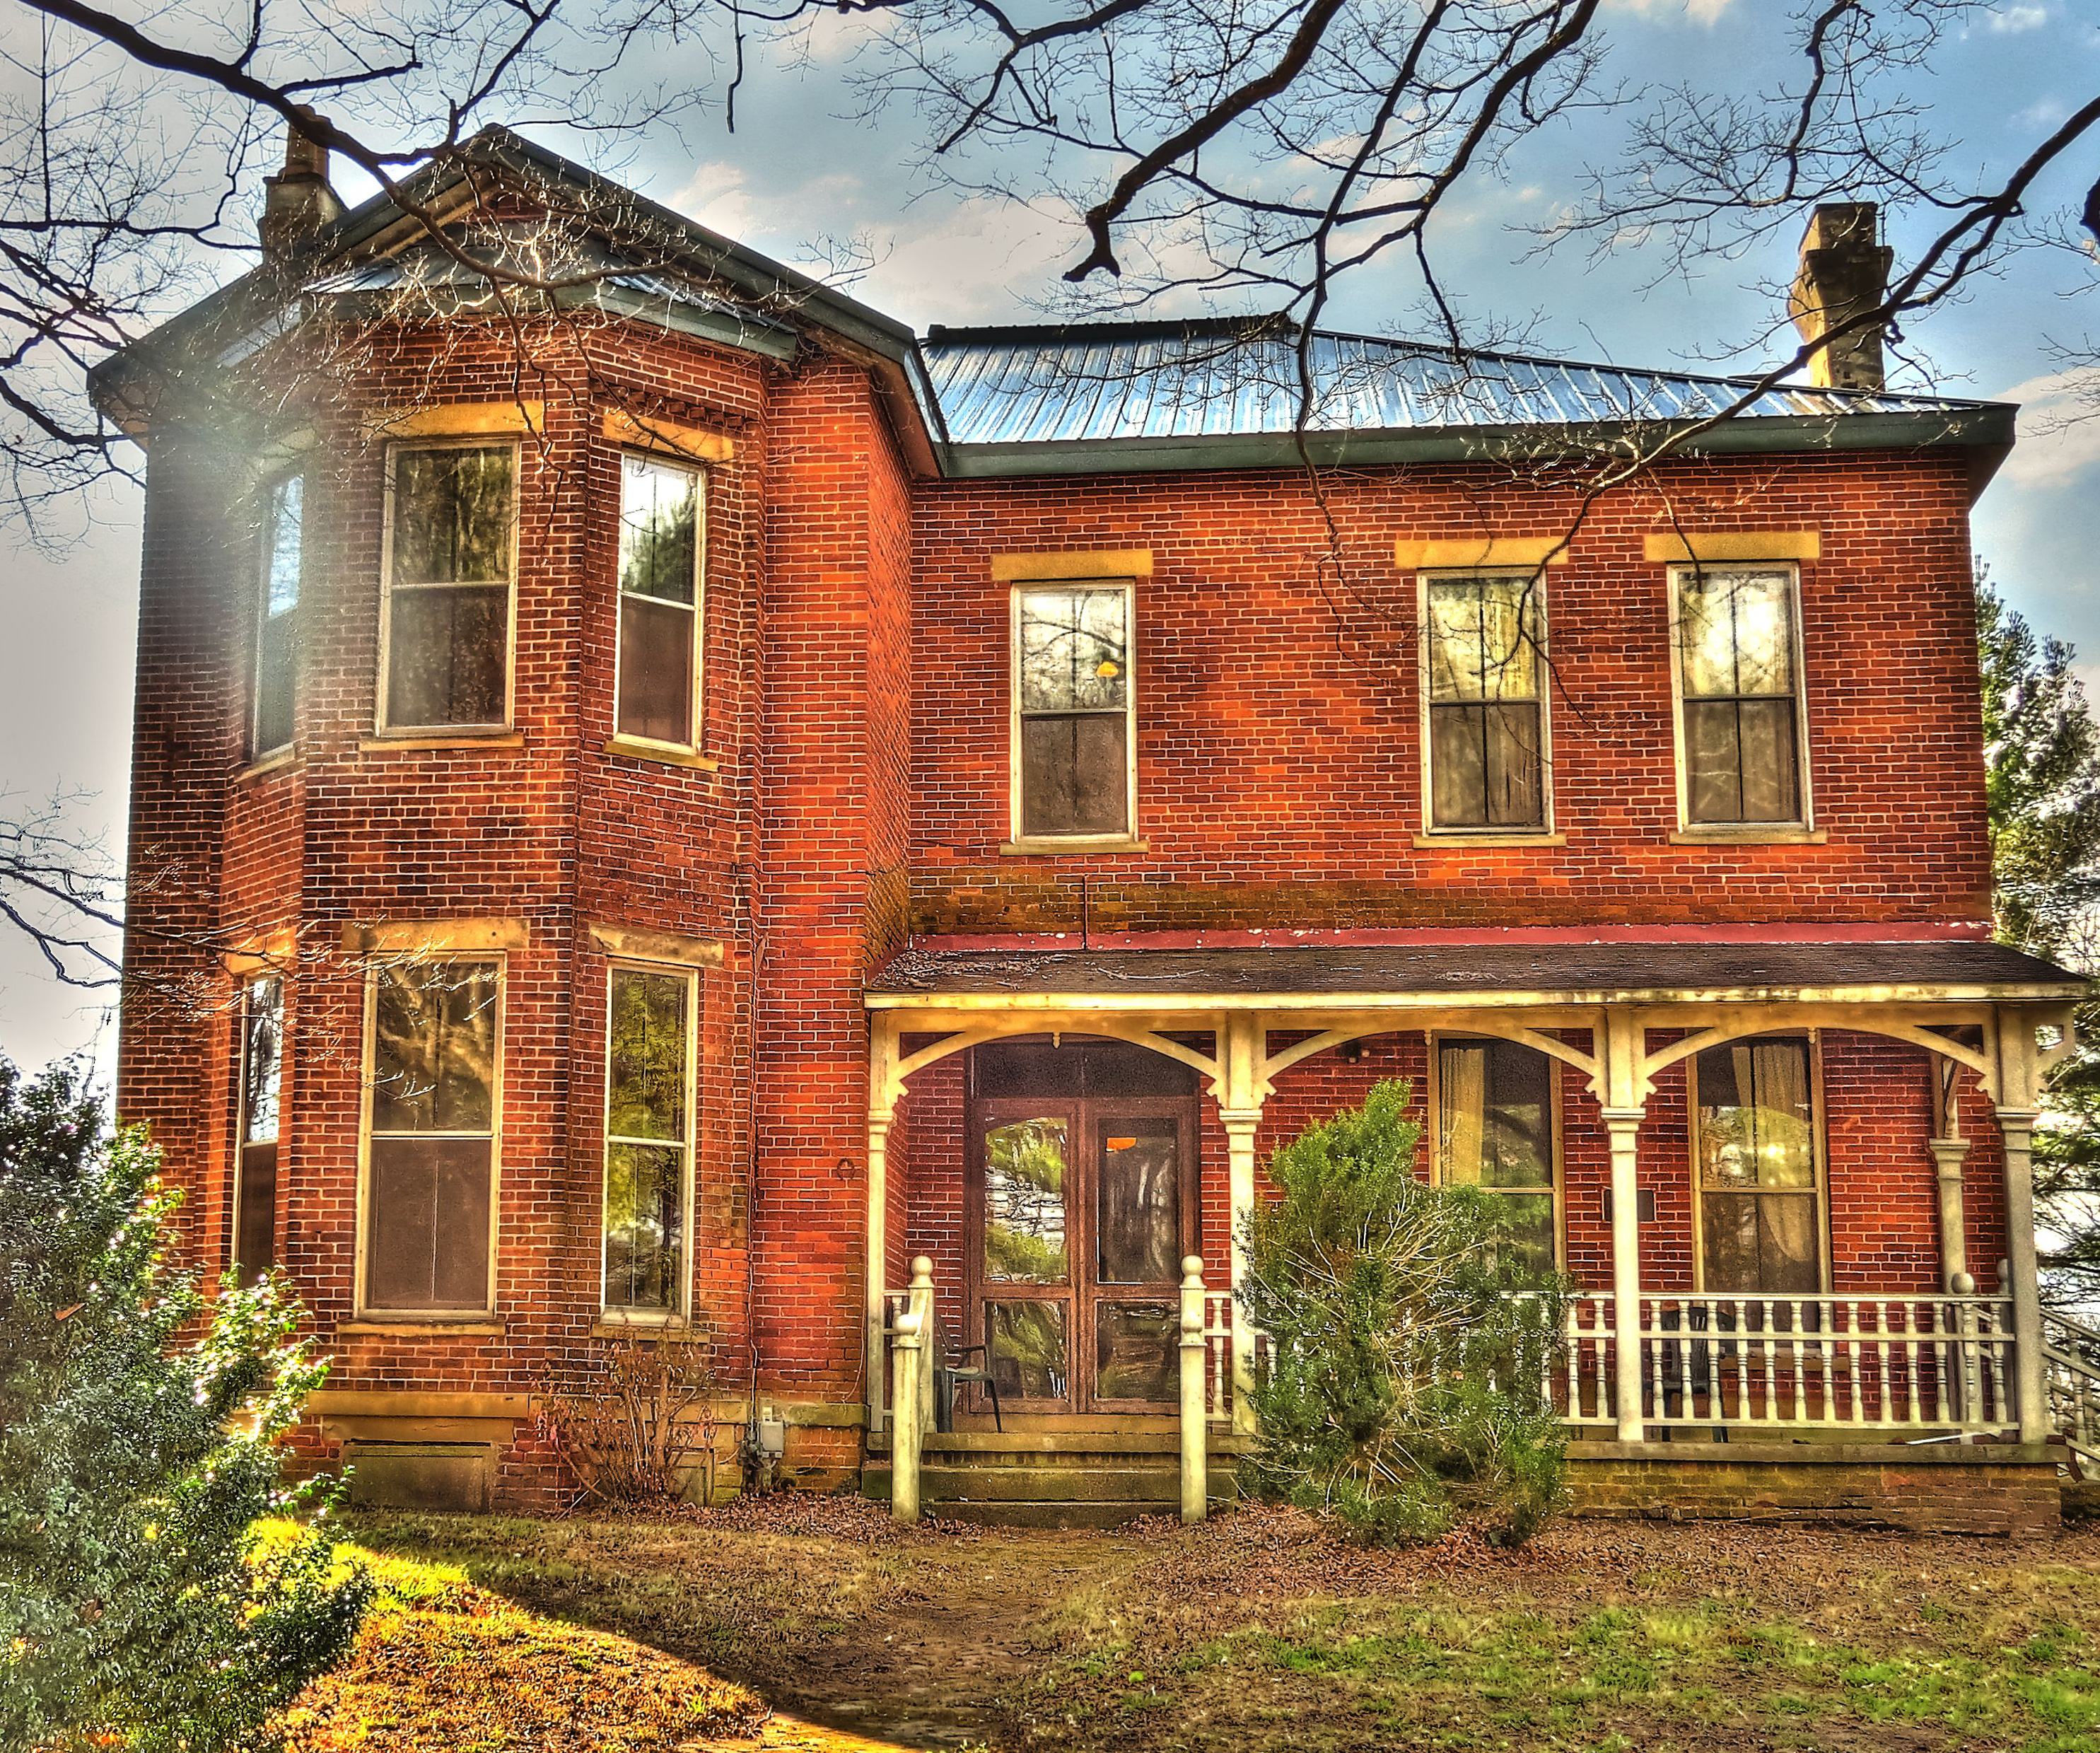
[{"x1": 1241, "y1": 1083, "x2": 1567, "y2": 1545}]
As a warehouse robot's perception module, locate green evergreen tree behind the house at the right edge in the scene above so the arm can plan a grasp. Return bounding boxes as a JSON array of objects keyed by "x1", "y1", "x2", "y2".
[{"x1": 1976, "y1": 565, "x2": 2100, "y2": 1306}]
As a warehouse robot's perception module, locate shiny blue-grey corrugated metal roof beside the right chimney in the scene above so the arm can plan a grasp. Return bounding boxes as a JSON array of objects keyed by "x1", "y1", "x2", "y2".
[{"x1": 920, "y1": 323, "x2": 1985, "y2": 445}]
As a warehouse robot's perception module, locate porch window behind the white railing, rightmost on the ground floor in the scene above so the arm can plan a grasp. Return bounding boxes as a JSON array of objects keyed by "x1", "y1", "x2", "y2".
[{"x1": 1693, "y1": 1039, "x2": 1823, "y2": 1293}]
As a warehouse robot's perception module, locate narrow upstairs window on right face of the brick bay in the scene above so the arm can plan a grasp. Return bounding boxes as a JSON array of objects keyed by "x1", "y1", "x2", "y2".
[{"x1": 615, "y1": 453, "x2": 706, "y2": 750}]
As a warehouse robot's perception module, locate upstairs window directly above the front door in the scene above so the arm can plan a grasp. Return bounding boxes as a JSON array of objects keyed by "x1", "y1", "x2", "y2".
[{"x1": 1013, "y1": 583, "x2": 1136, "y2": 842}]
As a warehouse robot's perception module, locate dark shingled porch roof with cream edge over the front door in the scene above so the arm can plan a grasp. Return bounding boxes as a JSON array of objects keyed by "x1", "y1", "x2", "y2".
[{"x1": 868, "y1": 938, "x2": 2087, "y2": 1010}]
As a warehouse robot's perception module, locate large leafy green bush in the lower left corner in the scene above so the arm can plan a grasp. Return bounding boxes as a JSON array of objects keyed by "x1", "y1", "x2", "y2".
[{"x1": 0, "y1": 1060, "x2": 372, "y2": 1753}]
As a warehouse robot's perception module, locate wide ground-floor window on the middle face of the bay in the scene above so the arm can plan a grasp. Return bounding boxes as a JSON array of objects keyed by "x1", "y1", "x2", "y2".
[{"x1": 366, "y1": 960, "x2": 502, "y2": 1315}]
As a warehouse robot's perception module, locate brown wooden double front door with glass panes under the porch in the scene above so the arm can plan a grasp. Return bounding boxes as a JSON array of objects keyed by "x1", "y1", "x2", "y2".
[{"x1": 968, "y1": 1042, "x2": 1197, "y2": 1413}]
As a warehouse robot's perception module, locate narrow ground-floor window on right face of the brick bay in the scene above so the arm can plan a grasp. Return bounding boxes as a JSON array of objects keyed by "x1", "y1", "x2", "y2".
[{"x1": 605, "y1": 968, "x2": 693, "y2": 1315}]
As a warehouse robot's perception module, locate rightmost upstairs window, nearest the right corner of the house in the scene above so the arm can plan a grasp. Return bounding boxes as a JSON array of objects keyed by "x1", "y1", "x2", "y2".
[{"x1": 1674, "y1": 567, "x2": 1806, "y2": 827}]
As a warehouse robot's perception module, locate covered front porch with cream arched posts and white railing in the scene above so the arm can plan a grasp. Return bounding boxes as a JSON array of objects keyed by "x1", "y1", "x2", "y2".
[{"x1": 865, "y1": 934, "x2": 2089, "y2": 1506}]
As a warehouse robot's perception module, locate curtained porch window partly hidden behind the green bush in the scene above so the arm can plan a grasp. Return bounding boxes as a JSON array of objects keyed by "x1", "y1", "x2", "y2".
[{"x1": 1436, "y1": 1042, "x2": 1558, "y2": 1272}]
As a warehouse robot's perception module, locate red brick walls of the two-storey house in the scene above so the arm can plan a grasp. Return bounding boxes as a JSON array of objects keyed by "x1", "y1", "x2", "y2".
[{"x1": 119, "y1": 230, "x2": 2032, "y2": 1503}]
